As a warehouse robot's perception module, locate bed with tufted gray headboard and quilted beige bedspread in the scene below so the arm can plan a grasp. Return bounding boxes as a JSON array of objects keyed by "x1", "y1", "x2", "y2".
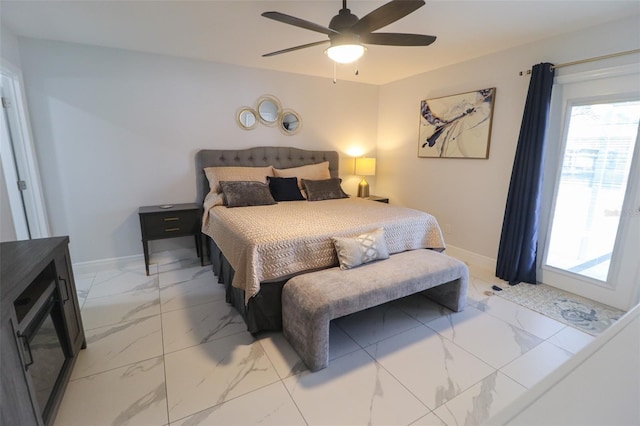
[{"x1": 196, "y1": 147, "x2": 444, "y2": 333}]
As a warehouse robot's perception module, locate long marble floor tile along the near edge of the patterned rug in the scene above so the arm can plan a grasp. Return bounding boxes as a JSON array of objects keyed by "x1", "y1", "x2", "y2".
[{"x1": 476, "y1": 296, "x2": 566, "y2": 339}]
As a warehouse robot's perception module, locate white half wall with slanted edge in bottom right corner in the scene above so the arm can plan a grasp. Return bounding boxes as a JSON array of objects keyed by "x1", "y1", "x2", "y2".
[{"x1": 486, "y1": 305, "x2": 640, "y2": 426}]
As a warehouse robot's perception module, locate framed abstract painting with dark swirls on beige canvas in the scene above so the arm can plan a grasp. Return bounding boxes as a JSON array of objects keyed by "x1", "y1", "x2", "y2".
[{"x1": 418, "y1": 87, "x2": 496, "y2": 158}]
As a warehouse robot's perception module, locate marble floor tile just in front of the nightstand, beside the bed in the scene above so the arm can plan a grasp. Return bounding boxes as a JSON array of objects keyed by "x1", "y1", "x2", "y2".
[{"x1": 160, "y1": 274, "x2": 225, "y2": 312}]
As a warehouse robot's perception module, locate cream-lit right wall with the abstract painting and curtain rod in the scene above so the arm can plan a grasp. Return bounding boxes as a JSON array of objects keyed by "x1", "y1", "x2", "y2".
[{"x1": 376, "y1": 16, "x2": 640, "y2": 264}]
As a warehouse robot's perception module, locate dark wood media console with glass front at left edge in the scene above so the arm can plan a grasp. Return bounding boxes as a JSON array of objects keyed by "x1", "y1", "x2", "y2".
[{"x1": 0, "y1": 237, "x2": 86, "y2": 426}]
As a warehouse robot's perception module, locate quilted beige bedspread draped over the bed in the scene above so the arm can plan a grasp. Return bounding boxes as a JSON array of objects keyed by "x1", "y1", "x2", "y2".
[{"x1": 202, "y1": 198, "x2": 445, "y2": 303}]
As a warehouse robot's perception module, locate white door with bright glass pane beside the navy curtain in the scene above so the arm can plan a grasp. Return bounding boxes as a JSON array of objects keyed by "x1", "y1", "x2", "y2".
[{"x1": 539, "y1": 67, "x2": 640, "y2": 310}]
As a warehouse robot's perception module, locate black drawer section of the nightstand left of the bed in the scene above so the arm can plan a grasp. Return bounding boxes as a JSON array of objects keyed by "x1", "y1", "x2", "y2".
[{"x1": 140, "y1": 211, "x2": 200, "y2": 239}]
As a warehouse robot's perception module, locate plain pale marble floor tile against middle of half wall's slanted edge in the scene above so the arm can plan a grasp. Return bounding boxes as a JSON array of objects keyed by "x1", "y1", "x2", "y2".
[{"x1": 500, "y1": 342, "x2": 572, "y2": 389}]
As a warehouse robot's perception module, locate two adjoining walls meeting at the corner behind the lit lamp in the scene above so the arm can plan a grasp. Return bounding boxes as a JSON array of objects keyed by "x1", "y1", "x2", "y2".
[{"x1": 12, "y1": 17, "x2": 640, "y2": 264}]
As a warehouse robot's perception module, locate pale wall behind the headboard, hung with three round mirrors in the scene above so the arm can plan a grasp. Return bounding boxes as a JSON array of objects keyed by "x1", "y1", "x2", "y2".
[{"x1": 20, "y1": 38, "x2": 379, "y2": 262}]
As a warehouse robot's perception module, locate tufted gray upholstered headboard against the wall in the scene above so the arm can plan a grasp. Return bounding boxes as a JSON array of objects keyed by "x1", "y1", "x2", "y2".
[{"x1": 196, "y1": 146, "x2": 339, "y2": 204}]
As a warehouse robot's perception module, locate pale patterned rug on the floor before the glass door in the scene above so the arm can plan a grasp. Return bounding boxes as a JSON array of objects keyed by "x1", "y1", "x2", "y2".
[{"x1": 495, "y1": 283, "x2": 625, "y2": 336}]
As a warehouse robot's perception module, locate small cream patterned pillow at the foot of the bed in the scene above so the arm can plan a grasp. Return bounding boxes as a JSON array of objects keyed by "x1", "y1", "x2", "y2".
[{"x1": 331, "y1": 228, "x2": 389, "y2": 270}]
